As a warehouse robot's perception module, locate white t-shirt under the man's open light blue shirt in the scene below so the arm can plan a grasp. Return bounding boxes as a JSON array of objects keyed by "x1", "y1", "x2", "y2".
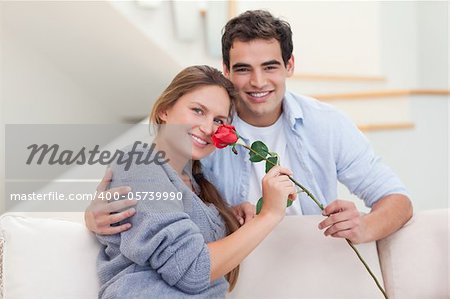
[{"x1": 235, "y1": 116, "x2": 302, "y2": 215}]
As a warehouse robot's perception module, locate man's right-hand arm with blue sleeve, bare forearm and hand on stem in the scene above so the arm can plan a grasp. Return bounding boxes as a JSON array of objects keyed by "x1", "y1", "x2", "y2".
[{"x1": 319, "y1": 108, "x2": 412, "y2": 243}]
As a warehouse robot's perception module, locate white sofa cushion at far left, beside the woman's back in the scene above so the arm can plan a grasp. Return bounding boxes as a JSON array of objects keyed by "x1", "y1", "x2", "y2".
[{"x1": 0, "y1": 214, "x2": 99, "y2": 299}]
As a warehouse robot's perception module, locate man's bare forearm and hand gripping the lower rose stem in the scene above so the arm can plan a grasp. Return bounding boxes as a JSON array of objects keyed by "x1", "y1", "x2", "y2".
[{"x1": 319, "y1": 194, "x2": 413, "y2": 243}]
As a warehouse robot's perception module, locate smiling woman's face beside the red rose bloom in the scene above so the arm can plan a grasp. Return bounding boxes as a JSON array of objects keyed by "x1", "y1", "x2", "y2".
[{"x1": 159, "y1": 85, "x2": 230, "y2": 160}]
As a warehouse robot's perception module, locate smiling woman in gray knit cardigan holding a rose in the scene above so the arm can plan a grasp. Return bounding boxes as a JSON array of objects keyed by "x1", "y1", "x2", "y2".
[{"x1": 97, "y1": 66, "x2": 296, "y2": 299}]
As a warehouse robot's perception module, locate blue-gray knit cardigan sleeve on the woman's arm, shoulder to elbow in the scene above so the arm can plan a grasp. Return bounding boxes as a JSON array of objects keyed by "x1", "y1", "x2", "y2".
[{"x1": 111, "y1": 158, "x2": 210, "y2": 294}]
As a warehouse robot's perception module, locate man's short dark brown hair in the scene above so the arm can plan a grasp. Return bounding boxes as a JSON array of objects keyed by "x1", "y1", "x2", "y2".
[{"x1": 222, "y1": 10, "x2": 293, "y2": 69}]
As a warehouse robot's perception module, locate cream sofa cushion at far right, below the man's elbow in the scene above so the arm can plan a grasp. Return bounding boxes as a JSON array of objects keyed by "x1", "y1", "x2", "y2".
[{"x1": 378, "y1": 209, "x2": 450, "y2": 299}]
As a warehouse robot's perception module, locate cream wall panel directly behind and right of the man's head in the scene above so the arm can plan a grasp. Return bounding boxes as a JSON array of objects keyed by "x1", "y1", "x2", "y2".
[{"x1": 237, "y1": 1, "x2": 382, "y2": 76}]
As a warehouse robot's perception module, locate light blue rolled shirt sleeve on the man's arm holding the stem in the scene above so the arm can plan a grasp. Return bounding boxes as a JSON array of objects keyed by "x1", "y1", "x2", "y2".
[{"x1": 333, "y1": 113, "x2": 408, "y2": 207}]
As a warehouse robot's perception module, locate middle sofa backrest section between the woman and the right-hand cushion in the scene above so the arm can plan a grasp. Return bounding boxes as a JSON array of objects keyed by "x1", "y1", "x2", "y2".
[{"x1": 228, "y1": 215, "x2": 383, "y2": 299}]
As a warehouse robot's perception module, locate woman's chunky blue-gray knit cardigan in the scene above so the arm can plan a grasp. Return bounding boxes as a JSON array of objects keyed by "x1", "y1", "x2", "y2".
[{"x1": 97, "y1": 149, "x2": 228, "y2": 299}]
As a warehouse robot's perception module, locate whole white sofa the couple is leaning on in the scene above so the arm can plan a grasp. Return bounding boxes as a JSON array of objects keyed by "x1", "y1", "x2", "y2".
[{"x1": 0, "y1": 210, "x2": 450, "y2": 299}]
